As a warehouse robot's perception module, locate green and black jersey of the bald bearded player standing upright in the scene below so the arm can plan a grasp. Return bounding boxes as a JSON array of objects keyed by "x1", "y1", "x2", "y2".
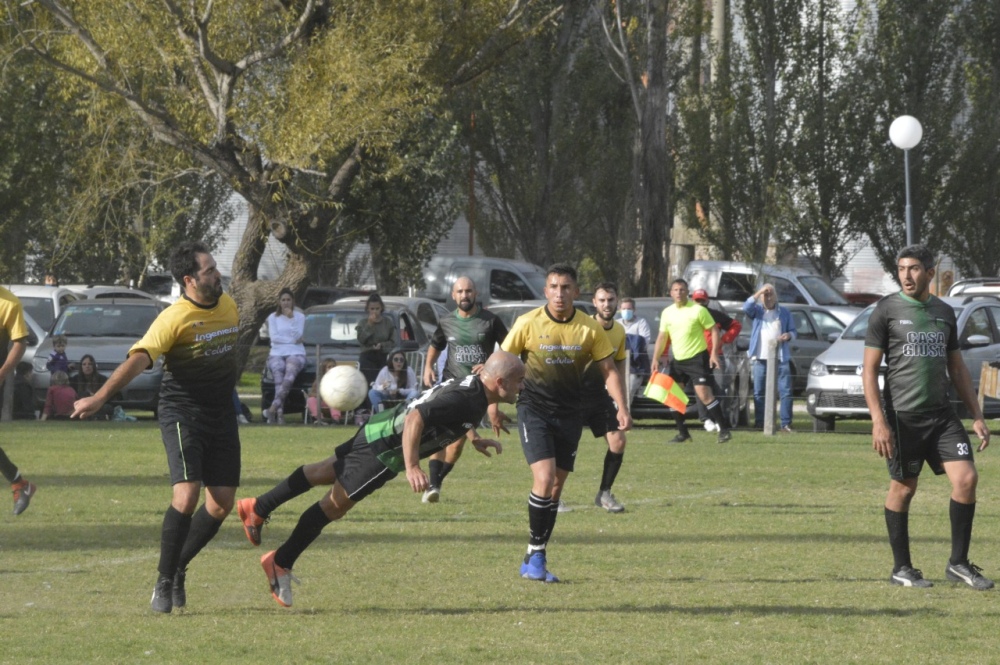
[{"x1": 431, "y1": 308, "x2": 507, "y2": 380}]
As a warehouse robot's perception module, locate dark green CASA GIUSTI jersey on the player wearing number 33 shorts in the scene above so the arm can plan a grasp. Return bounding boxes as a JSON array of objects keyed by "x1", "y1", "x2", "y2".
[{"x1": 865, "y1": 293, "x2": 958, "y2": 412}]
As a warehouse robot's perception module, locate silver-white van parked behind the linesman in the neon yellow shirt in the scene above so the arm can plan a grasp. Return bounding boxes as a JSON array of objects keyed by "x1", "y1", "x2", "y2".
[{"x1": 684, "y1": 261, "x2": 862, "y2": 326}]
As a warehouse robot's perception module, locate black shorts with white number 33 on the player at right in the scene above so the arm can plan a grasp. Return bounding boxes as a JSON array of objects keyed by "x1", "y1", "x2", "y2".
[{"x1": 886, "y1": 408, "x2": 975, "y2": 480}]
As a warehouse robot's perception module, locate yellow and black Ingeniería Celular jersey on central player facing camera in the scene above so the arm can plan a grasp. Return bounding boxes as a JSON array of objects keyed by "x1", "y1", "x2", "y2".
[{"x1": 501, "y1": 306, "x2": 612, "y2": 413}]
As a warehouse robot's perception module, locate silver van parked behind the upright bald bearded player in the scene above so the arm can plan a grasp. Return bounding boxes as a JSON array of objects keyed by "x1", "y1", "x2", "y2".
[{"x1": 415, "y1": 255, "x2": 545, "y2": 307}]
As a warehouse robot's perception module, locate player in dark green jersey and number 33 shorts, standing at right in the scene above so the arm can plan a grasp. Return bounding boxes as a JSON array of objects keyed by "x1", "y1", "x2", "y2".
[{"x1": 861, "y1": 245, "x2": 993, "y2": 590}]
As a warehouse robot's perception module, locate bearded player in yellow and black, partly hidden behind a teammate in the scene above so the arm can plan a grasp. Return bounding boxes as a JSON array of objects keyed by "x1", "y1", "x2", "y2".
[{"x1": 583, "y1": 282, "x2": 628, "y2": 513}]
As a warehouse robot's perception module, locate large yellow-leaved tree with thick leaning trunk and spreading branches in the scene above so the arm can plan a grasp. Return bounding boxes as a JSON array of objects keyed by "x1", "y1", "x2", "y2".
[{"x1": 3, "y1": 0, "x2": 556, "y2": 366}]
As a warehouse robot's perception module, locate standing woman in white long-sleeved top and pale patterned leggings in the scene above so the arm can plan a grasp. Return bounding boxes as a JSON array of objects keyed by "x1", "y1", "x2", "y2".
[{"x1": 264, "y1": 288, "x2": 306, "y2": 425}]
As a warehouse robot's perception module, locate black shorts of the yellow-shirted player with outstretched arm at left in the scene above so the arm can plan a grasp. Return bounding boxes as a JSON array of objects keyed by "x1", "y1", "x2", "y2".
[{"x1": 160, "y1": 417, "x2": 240, "y2": 487}]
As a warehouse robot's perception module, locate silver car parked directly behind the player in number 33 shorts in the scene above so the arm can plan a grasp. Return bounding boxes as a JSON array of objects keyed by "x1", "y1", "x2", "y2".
[{"x1": 806, "y1": 296, "x2": 1000, "y2": 431}]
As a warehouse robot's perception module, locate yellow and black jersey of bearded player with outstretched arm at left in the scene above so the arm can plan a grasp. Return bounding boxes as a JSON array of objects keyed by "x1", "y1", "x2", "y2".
[{"x1": 128, "y1": 293, "x2": 239, "y2": 419}]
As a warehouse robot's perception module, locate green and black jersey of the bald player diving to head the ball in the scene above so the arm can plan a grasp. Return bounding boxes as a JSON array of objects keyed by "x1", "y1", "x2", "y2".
[{"x1": 361, "y1": 374, "x2": 489, "y2": 473}]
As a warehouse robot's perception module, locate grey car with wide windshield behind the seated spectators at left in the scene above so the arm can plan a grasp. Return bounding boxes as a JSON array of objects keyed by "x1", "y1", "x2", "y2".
[{"x1": 29, "y1": 298, "x2": 168, "y2": 412}]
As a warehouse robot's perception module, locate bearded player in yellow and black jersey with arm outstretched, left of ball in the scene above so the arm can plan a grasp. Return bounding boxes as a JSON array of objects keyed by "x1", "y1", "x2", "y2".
[{"x1": 72, "y1": 242, "x2": 240, "y2": 612}]
